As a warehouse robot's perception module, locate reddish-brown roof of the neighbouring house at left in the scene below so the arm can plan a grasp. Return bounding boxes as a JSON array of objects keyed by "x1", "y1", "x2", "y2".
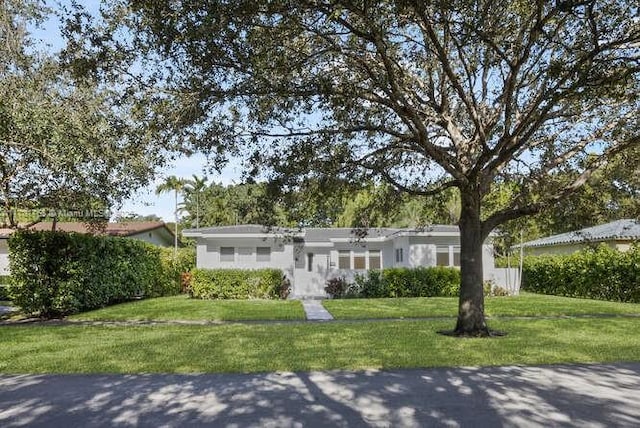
[{"x1": 0, "y1": 221, "x2": 173, "y2": 238}]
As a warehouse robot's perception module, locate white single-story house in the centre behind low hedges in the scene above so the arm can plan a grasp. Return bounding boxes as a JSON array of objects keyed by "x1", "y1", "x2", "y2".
[{"x1": 182, "y1": 225, "x2": 520, "y2": 298}]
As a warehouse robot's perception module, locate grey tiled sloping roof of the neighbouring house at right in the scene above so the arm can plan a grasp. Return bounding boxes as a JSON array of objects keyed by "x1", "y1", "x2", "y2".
[{"x1": 518, "y1": 219, "x2": 640, "y2": 247}]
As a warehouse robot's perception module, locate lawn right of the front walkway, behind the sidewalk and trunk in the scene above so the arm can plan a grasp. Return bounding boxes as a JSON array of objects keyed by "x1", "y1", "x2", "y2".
[{"x1": 323, "y1": 293, "x2": 640, "y2": 319}]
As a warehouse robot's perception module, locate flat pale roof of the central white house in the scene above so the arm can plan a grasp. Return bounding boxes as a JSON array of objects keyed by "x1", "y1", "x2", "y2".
[{"x1": 182, "y1": 224, "x2": 460, "y2": 242}]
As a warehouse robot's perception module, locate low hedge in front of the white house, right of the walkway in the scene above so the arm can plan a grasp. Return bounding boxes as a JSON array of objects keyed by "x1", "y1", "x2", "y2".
[{"x1": 327, "y1": 266, "x2": 460, "y2": 298}]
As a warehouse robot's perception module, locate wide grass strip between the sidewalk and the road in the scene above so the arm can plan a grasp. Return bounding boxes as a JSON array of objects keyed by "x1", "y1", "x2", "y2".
[{"x1": 0, "y1": 318, "x2": 640, "y2": 373}]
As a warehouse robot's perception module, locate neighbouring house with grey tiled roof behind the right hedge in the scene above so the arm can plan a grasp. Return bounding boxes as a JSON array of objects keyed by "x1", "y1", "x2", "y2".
[{"x1": 517, "y1": 219, "x2": 640, "y2": 256}]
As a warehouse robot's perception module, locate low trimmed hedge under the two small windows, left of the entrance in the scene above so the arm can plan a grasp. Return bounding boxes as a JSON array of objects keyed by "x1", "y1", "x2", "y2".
[{"x1": 189, "y1": 269, "x2": 289, "y2": 299}]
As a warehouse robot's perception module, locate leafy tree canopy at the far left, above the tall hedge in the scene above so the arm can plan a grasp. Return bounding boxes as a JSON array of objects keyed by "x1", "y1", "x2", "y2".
[{"x1": 0, "y1": 0, "x2": 163, "y2": 228}]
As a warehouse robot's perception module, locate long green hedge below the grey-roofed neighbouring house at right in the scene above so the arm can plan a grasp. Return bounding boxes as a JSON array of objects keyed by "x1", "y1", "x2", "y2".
[{"x1": 522, "y1": 245, "x2": 640, "y2": 303}]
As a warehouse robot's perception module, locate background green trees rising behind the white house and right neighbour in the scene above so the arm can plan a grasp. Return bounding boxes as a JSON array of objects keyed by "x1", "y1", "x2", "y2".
[{"x1": 171, "y1": 155, "x2": 640, "y2": 251}]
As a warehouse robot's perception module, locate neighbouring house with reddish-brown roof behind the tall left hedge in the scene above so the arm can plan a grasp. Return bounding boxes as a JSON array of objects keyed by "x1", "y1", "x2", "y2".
[{"x1": 0, "y1": 221, "x2": 174, "y2": 275}]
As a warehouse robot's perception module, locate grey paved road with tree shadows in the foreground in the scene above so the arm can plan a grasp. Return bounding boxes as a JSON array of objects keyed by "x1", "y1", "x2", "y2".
[{"x1": 0, "y1": 363, "x2": 640, "y2": 427}]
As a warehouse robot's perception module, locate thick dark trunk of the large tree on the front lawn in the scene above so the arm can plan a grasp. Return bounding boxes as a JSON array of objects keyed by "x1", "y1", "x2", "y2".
[{"x1": 453, "y1": 190, "x2": 489, "y2": 336}]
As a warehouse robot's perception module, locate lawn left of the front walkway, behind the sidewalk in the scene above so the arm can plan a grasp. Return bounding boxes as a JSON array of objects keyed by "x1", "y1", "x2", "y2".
[{"x1": 69, "y1": 295, "x2": 305, "y2": 321}]
